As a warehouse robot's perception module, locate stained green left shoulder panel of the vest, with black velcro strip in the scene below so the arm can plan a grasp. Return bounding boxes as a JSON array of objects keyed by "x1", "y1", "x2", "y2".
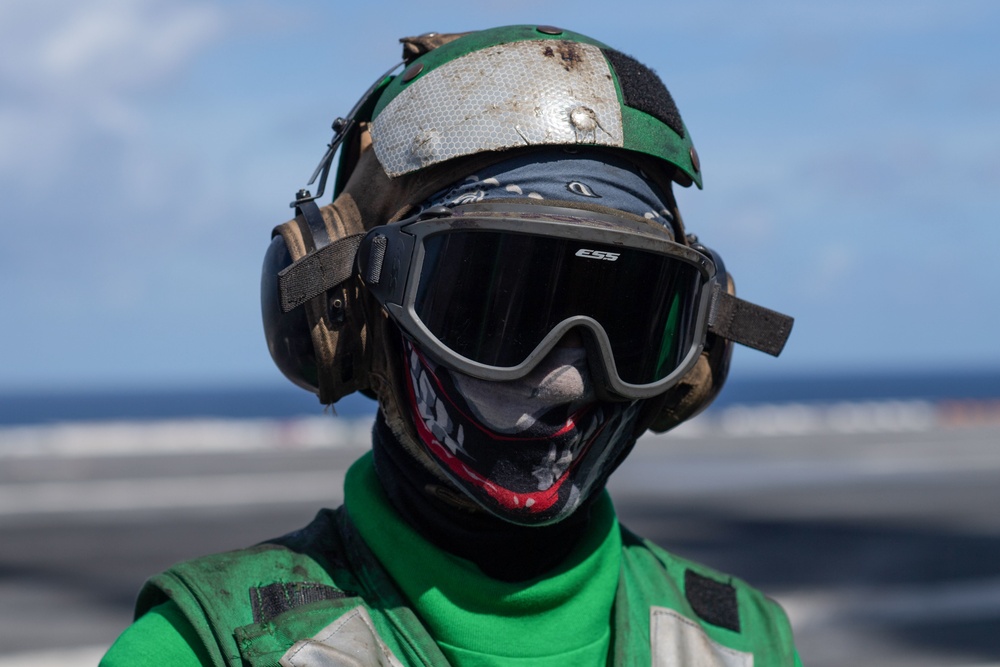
[{"x1": 136, "y1": 508, "x2": 447, "y2": 667}]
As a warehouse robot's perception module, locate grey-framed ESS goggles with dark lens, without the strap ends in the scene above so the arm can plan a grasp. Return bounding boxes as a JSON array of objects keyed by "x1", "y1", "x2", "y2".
[{"x1": 357, "y1": 203, "x2": 790, "y2": 399}]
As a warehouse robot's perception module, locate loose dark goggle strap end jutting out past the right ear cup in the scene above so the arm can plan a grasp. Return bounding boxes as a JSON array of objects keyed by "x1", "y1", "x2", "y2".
[{"x1": 708, "y1": 290, "x2": 795, "y2": 357}]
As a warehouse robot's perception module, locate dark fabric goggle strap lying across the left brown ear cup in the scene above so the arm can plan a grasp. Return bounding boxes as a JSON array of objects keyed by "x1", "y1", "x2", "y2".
[{"x1": 278, "y1": 234, "x2": 365, "y2": 313}]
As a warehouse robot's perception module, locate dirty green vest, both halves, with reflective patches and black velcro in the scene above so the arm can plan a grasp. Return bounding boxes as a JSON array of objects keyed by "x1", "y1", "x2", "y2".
[{"x1": 136, "y1": 508, "x2": 801, "y2": 667}]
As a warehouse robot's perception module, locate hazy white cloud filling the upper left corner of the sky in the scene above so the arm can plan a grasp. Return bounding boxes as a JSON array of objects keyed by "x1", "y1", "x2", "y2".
[{"x1": 0, "y1": 0, "x2": 224, "y2": 181}]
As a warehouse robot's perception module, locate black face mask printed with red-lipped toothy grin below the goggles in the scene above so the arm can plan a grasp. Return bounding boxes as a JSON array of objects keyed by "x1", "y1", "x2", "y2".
[{"x1": 403, "y1": 341, "x2": 640, "y2": 525}]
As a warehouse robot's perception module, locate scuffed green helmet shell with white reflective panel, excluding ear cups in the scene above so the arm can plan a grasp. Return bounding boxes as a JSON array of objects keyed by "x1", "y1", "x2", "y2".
[{"x1": 337, "y1": 25, "x2": 701, "y2": 198}]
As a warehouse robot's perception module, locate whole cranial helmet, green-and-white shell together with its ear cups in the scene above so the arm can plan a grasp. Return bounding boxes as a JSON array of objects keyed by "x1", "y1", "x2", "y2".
[{"x1": 261, "y1": 26, "x2": 791, "y2": 444}]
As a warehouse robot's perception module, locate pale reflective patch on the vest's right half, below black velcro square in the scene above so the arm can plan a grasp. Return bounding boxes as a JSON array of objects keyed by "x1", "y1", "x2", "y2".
[{"x1": 649, "y1": 607, "x2": 753, "y2": 667}]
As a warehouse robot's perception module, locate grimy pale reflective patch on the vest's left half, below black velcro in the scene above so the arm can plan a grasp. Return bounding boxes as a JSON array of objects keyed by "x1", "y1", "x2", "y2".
[{"x1": 279, "y1": 607, "x2": 403, "y2": 667}]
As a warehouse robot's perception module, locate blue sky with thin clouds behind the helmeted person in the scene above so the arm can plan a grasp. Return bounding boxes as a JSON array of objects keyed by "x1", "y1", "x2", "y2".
[{"x1": 0, "y1": 0, "x2": 1000, "y2": 390}]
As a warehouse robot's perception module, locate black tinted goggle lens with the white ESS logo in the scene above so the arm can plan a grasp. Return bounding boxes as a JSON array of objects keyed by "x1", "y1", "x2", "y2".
[{"x1": 414, "y1": 230, "x2": 701, "y2": 385}]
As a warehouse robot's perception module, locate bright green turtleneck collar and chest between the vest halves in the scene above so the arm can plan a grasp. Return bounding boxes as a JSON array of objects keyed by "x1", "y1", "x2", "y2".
[{"x1": 344, "y1": 455, "x2": 621, "y2": 667}]
